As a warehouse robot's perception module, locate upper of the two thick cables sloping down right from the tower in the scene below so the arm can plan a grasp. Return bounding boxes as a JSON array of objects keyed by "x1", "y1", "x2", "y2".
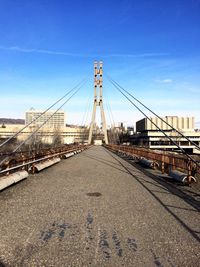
[{"x1": 107, "y1": 75, "x2": 200, "y2": 150}]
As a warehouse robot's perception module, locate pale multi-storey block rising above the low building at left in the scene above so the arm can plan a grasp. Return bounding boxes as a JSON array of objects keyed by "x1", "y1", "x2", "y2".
[{"x1": 25, "y1": 109, "x2": 65, "y2": 129}]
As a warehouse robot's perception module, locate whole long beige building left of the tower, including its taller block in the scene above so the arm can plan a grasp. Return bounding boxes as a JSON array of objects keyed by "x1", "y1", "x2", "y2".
[{"x1": 0, "y1": 108, "x2": 89, "y2": 144}]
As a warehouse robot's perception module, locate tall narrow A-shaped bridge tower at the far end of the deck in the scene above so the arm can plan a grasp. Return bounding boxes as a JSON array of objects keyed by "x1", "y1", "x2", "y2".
[{"x1": 88, "y1": 61, "x2": 108, "y2": 144}]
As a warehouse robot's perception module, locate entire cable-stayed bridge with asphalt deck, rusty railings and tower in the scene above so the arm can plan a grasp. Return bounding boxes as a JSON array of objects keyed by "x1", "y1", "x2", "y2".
[{"x1": 0, "y1": 63, "x2": 200, "y2": 266}]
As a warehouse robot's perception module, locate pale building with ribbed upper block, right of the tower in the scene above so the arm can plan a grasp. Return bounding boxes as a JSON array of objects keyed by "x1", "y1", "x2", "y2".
[{"x1": 131, "y1": 116, "x2": 200, "y2": 153}]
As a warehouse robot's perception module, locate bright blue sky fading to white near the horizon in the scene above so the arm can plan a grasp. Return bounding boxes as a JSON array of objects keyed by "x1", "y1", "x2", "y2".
[{"x1": 0, "y1": 0, "x2": 200, "y2": 128}]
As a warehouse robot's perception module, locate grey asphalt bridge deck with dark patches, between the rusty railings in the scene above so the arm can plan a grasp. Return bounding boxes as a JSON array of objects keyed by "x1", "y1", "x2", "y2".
[{"x1": 0, "y1": 147, "x2": 200, "y2": 267}]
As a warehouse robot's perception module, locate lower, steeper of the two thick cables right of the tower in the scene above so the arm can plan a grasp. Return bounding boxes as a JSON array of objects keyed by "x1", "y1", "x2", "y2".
[{"x1": 108, "y1": 78, "x2": 200, "y2": 167}]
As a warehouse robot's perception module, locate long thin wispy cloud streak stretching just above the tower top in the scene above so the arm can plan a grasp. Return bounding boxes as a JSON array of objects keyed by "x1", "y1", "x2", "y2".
[{"x1": 0, "y1": 46, "x2": 169, "y2": 58}]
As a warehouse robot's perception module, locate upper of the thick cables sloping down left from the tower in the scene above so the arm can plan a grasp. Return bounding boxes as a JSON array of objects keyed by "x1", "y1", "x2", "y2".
[{"x1": 0, "y1": 80, "x2": 85, "y2": 150}]
